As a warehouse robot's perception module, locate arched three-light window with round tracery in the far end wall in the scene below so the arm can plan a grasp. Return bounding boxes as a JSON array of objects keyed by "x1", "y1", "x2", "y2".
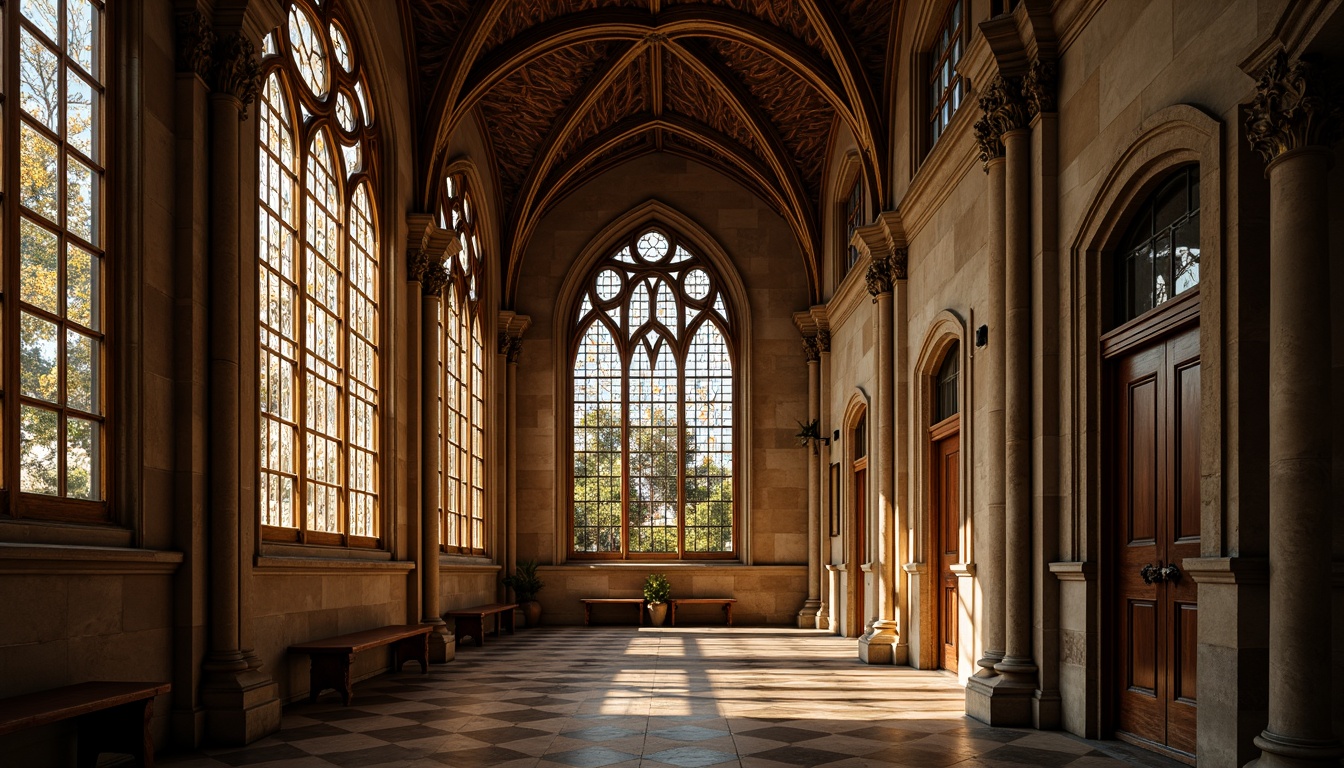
[{"x1": 570, "y1": 227, "x2": 738, "y2": 558}]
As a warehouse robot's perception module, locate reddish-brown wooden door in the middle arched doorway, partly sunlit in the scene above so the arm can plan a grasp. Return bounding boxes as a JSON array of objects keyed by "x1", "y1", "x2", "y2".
[{"x1": 929, "y1": 425, "x2": 961, "y2": 671}]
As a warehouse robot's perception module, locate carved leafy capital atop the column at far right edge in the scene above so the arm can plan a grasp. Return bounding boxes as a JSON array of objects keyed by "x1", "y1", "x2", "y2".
[{"x1": 1246, "y1": 50, "x2": 1344, "y2": 163}]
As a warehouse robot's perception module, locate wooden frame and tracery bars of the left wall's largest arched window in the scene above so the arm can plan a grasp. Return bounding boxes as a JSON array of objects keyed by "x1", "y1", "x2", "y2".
[{"x1": 257, "y1": 0, "x2": 387, "y2": 549}]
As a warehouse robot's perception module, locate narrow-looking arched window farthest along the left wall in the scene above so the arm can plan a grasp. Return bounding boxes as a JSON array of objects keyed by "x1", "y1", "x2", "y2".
[{"x1": 439, "y1": 174, "x2": 485, "y2": 554}]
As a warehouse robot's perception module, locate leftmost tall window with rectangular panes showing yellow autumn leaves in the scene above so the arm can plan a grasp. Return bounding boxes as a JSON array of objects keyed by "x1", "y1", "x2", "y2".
[{"x1": 0, "y1": 0, "x2": 110, "y2": 522}]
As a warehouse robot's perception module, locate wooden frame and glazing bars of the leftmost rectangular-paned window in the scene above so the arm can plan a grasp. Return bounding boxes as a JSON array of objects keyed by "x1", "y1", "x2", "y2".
[{"x1": 0, "y1": 0, "x2": 121, "y2": 526}]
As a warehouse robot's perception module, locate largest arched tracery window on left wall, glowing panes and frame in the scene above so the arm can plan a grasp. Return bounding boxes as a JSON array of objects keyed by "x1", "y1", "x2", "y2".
[{"x1": 257, "y1": 0, "x2": 382, "y2": 546}]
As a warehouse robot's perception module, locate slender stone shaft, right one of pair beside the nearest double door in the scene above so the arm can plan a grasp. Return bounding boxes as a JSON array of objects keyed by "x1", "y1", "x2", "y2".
[{"x1": 995, "y1": 129, "x2": 1036, "y2": 682}]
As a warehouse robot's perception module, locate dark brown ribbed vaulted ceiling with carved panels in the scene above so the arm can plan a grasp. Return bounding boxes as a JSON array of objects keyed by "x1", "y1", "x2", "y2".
[{"x1": 403, "y1": 0, "x2": 898, "y2": 303}]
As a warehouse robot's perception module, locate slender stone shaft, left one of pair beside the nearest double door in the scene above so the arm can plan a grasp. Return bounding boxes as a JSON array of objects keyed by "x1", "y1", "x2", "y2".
[{"x1": 974, "y1": 157, "x2": 1007, "y2": 677}]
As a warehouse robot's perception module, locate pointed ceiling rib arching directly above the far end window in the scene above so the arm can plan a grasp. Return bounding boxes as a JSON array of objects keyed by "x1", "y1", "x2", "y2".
[{"x1": 504, "y1": 113, "x2": 818, "y2": 301}]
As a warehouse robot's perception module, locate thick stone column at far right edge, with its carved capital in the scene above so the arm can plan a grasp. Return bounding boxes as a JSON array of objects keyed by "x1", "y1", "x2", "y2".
[{"x1": 1246, "y1": 51, "x2": 1344, "y2": 767}]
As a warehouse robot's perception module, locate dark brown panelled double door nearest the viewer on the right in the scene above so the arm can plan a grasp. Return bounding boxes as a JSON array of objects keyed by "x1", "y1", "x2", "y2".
[{"x1": 1110, "y1": 328, "x2": 1200, "y2": 755}]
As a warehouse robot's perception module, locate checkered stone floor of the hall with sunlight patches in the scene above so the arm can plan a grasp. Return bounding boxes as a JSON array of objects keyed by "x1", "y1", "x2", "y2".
[{"x1": 160, "y1": 627, "x2": 1175, "y2": 768}]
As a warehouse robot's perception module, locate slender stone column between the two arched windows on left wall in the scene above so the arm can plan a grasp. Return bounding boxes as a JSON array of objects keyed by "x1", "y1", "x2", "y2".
[{"x1": 410, "y1": 228, "x2": 457, "y2": 663}]
